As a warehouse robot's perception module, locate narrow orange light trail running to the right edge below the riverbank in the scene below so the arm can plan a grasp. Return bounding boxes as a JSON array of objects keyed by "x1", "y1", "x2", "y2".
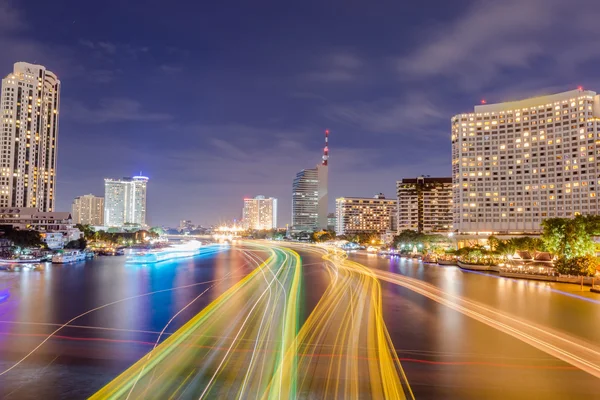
[{"x1": 372, "y1": 270, "x2": 600, "y2": 378}]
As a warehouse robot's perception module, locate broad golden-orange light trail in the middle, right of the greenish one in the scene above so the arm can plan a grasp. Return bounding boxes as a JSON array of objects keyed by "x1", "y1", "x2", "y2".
[{"x1": 262, "y1": 247, "x2": 413, "y2": 399}]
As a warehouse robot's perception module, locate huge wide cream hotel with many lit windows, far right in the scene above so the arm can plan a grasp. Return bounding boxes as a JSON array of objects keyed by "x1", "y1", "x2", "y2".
[{"x1": 452, "y1": 88, "x2": 600, "y2": 233}]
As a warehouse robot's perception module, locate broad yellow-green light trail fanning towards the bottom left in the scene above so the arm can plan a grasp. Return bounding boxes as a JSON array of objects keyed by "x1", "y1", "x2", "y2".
[{"x1": 93, "y1": 245, "x2": 301, "y2": 398}]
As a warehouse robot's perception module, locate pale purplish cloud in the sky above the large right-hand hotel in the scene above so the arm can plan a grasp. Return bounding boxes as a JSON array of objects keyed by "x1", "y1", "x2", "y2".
[{"x1": 398, "y1": 0, "x2": 600, "y2": 89}]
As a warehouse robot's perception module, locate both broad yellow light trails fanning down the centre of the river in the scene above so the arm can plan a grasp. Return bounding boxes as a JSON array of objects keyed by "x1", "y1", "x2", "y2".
[{"x1": 92, "y1": 242, "x2": 413, "y2": 400}]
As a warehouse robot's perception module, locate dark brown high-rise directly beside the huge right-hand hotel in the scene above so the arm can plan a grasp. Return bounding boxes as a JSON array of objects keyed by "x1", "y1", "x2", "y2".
[{"x1": 396, "y1": 176, "x2": 452, "y2": 232}]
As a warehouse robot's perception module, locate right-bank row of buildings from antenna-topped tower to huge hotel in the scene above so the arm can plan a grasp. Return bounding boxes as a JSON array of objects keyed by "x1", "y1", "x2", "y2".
[{"x1": 292, "y1": 88, "x2": 600, "y2": 244}]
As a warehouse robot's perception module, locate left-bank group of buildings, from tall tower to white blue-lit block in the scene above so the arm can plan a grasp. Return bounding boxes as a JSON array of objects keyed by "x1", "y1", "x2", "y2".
[{"x1": 0, "y1": 62, "x2": 148, "y2": 248}]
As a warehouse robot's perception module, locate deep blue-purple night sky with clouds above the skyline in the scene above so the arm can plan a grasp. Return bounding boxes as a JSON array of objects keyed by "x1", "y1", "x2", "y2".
[{"x1": 0, "y1": 0, "x2": 600, "y2": 226}]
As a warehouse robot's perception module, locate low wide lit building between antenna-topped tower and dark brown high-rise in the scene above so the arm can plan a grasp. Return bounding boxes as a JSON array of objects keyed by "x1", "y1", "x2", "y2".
[{"x1": 335, "y1": 193, "x2": 397, "y2": 235}]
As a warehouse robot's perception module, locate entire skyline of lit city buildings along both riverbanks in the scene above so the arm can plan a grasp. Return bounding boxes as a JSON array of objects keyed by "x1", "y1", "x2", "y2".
[{"x1": 7, "y1": 62, "x2": 600, "y2": 247}]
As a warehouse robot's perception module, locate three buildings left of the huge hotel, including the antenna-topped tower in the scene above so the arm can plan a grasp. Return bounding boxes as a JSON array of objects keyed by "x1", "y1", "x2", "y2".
[{"x1": 291, "y1": 131, "x2": 453, "y2": 238}]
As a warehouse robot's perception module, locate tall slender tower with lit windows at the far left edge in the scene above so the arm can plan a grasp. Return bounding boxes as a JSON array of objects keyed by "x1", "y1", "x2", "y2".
[{"x1": 0, "y1": 62, "x2": 60, "y2": 212}]
